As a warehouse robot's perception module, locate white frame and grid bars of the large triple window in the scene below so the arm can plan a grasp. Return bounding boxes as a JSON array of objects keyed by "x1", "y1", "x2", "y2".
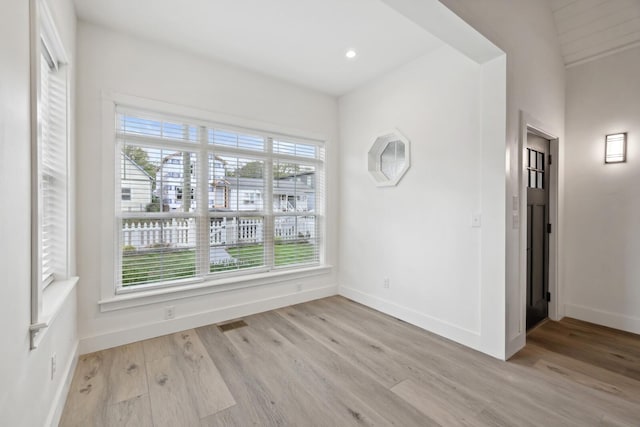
[{"x1": 115, "y1": 105, "x2": 325, "y2": 291}]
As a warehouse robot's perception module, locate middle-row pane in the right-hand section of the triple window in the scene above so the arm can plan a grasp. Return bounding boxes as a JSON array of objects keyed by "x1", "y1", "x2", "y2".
[{"x1": 273, "y1": 160, "x2": 316, "y2": 212}]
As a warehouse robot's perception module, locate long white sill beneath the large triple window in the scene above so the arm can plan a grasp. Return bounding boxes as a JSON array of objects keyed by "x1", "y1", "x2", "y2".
[{"x1": 98, "y1": 265, "x2": 333, "y2": 313}]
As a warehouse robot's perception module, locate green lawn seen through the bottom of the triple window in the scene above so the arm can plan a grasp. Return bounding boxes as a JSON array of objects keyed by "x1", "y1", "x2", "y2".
[{"x1": 122, "y1": 242, "x2": 316, "y2": 286}]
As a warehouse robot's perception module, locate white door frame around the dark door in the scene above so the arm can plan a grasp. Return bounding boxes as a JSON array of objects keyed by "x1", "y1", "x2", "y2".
[{"x1": 518, "y1": 111, "x2": 563, "y2": 334}]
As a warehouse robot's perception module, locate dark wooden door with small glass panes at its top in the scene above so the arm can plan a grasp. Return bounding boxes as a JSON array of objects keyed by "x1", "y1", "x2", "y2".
[{"x1": 525, "y1": 133, "x2": 551, "y2": 329}]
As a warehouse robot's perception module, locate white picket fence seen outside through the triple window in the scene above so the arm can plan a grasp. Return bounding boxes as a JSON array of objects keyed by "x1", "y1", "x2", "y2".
[{"x1": 122, "y1": 217, "x2": 316, "y2": 249}]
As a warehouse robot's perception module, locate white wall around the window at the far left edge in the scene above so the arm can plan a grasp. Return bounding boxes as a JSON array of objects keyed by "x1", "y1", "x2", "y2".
[{"x1": 0, "y1": 0, "x2": 77, "y2": 427}]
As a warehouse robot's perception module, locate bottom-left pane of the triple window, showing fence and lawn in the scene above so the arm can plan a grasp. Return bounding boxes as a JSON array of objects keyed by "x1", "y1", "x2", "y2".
[{"x1": 120, "y1": 217, "x2": 197, "y2": 286}]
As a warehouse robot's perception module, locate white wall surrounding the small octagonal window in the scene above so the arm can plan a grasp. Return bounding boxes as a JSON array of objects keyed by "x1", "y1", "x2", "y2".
[{"x1": 339, "y1": 46, "x2": 482, "y2": 354}]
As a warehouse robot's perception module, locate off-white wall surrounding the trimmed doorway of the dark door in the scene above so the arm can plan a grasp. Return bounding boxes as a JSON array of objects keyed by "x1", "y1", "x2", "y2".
[{"x1": 440, "y1": 0, "x2": 567, "y2": 357}]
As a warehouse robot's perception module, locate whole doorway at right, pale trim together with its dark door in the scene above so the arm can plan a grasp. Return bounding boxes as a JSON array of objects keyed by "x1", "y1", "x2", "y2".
[{"x1": 520, "y1": 111, "x2": 563, "y2": 344}]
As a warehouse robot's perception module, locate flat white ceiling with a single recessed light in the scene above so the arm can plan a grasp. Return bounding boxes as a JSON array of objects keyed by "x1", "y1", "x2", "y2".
[{"x1": 75, "y1": 0, "x2": 443, "y2": 95}]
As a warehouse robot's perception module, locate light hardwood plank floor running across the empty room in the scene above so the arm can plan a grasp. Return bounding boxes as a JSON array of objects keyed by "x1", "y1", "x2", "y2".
[{"x1": 61, "y1": 297, "x2": 640, "y2": 427}]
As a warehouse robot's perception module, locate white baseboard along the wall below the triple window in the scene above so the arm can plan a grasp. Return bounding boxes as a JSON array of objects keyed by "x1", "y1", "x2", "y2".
[{"x1": 80, "y1": 285, "x2": 338, "y2": 354}]
